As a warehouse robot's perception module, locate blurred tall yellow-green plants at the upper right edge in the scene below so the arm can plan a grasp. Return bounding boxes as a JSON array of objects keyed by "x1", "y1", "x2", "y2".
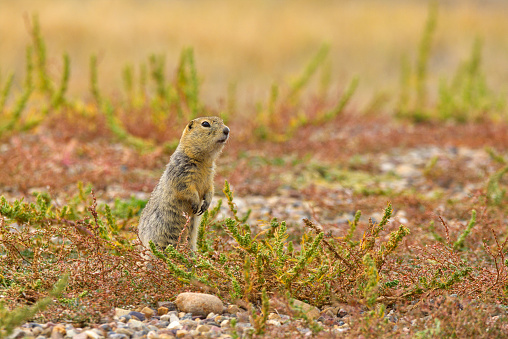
[{"x1": 397, "y1": 1, "x2": 506, "y2": 122}]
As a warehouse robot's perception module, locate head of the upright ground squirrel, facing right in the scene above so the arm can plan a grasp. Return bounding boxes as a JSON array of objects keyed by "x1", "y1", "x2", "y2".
[{"x1": 178, "y1": 117, "x2": 229, "y2": 161}]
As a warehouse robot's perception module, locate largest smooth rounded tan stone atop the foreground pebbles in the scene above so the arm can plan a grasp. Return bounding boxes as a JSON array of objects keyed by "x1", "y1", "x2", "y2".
[{"x1": 175, "y1": 293, "x2": 223, "y2": 316}]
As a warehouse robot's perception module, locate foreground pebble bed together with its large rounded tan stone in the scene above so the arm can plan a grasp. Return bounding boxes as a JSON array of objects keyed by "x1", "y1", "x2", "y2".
[{"x1": 8, "y1": 293, "x2": 349, "y2": 339}]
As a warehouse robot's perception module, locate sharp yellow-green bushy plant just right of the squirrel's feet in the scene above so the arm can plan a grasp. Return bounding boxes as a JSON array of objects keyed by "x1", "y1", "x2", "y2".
[{"x1": 151, "y1": 181, "x2": 409, "y2": 308}]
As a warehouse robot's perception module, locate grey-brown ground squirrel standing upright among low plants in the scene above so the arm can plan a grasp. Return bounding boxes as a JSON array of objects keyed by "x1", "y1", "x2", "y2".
[{"x1": 138, "y1": 117, "x2": 229, "y2": 250}]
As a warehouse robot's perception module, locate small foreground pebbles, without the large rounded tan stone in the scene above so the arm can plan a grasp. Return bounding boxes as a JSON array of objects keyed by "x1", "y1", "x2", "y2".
[{"x1": 8, "y1": 300, "x2": 358, "y2": 339}]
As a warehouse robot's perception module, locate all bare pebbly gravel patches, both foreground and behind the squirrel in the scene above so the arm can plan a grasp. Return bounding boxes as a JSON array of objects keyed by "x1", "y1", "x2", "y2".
[{"x1": 3, "y1": 147, "x2": 504, "y2": 339}]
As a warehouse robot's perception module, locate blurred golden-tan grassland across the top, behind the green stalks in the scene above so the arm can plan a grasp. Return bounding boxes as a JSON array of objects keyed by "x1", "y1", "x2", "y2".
[{"x1": 0, "y1": 0, "x2": 508, "y2": 113}]
